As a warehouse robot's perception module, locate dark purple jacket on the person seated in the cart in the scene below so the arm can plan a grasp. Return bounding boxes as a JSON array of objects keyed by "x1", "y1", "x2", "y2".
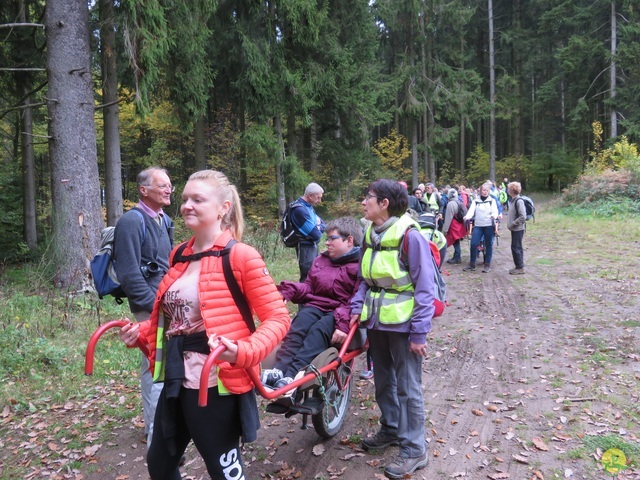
[{"x1": 278, "y1": 247, "x2": 360, "y2": 333}]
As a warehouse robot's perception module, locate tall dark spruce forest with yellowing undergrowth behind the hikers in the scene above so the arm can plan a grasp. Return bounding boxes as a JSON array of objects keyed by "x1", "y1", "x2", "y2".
[{"x1": 0, "y1": 0, "x2": 640, "y2": 288}]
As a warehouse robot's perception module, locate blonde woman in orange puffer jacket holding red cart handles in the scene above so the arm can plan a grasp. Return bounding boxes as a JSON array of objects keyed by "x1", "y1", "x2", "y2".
[{"x1": 120, "y1": 170, "x2": 290, "y2": 480}]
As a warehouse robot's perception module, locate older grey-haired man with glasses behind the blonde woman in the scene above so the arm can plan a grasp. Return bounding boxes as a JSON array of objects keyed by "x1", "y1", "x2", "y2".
[{"x1": 113, "y1": 167, "x2": 175, "y2": 445}]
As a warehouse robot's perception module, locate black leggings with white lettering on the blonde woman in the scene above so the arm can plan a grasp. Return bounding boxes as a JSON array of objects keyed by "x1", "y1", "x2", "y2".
[{"x1": 147, "y1": 387, "x2": 245, "y2": 480}]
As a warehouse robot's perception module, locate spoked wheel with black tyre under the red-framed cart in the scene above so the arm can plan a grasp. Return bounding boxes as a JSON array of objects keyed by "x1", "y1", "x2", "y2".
[{"x1": 311, "y1": 361, "x2": 353, "y2": 438}]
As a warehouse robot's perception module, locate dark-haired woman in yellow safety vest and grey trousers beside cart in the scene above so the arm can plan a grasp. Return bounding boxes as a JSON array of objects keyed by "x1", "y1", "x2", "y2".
[{"x1": 351, "y1": 179, "x2": 435, "y2": 478}]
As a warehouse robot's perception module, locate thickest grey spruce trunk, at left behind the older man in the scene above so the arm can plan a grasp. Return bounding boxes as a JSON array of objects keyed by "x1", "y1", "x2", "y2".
[{"x1": 45, "y1": 0, "x2": 103, "y2": 290}]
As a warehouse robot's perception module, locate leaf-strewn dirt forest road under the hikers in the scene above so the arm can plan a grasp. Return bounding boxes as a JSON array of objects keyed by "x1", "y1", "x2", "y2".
[{"x1": 85, "y1": 205, "x2": 640, "y2": 480}]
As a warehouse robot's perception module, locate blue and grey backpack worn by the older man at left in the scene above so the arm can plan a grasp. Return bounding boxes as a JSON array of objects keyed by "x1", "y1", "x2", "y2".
[{"x1": 90, "y1": 208, "x2": 147, "y2": 304}]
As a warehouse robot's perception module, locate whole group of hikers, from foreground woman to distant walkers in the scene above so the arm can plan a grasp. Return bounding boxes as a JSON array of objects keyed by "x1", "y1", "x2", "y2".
[{"x1": 104, "y1": 167, "x2": 524, "y2": 480}]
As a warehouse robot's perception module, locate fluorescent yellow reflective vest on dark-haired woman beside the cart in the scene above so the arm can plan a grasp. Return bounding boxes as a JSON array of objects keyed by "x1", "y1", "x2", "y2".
[{"x1": 360, "y1": 214, "x2": 420, "y2": 324}]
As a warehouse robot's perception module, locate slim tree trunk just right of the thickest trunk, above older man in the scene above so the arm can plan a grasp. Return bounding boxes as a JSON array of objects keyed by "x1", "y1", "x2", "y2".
[{"x1": 100, "y1": 0, "x2": 122, "y2": 225}]
